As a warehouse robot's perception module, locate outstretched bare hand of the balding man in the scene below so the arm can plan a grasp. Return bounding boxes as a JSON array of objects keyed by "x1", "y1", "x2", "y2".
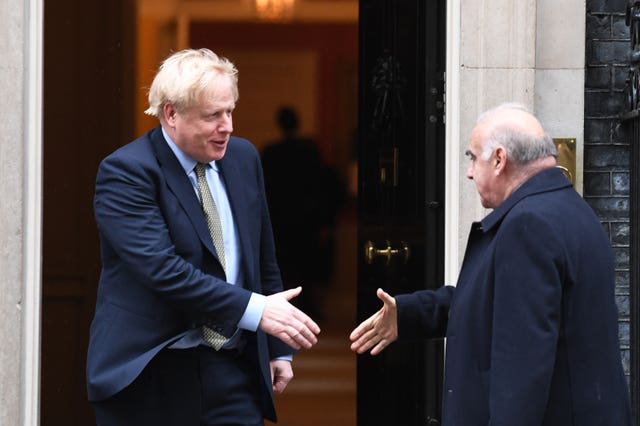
[{"x1": 349, "y1": 288, "x2": 398, "y2": 355}]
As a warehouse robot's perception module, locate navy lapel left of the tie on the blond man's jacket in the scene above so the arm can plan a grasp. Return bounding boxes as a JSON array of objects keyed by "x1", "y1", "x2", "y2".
[{"x1": 151, "y1": 127, "x2": 217, "y2": 257}]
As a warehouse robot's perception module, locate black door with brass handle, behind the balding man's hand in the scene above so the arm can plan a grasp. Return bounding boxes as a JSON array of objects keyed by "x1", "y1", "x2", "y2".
[{"x1": 357, "y1": 0, "x2": 446, "y2": 426}]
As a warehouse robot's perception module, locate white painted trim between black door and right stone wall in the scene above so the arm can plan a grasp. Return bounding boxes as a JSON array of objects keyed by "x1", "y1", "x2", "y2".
[{"x1": 444, "y1": 0, "x2": 461, "y2": 285}]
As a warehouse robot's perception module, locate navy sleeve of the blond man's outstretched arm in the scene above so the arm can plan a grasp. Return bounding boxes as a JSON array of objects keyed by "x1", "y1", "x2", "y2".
[{"x1": 94, "y1": 155, "x2": 251, "y2": 324}]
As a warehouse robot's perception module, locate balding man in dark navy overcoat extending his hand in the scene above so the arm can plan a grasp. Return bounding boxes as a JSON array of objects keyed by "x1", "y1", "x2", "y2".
[{"x1": 351, "y1": 104, "x2": 631, "y2": 426}]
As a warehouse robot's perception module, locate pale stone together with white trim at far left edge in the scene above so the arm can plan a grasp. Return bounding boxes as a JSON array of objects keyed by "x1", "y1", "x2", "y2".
[{"x1": 0, "y1": 0, "x2": 42, "y2": 425}]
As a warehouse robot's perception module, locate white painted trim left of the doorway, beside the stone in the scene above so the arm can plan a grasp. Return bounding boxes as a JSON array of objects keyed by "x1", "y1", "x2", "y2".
[{"x1": 20, "y1": 0, "x2": 44, "y2": 426}]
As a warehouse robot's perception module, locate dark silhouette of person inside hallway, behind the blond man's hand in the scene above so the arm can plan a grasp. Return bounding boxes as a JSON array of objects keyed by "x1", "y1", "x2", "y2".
[{"x1": 262, "y1": 106, "x2": 346, "y2": 320}]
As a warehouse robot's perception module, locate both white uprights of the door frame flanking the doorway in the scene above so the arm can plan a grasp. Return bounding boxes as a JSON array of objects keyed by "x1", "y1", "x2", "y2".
[{"x1": 20, "y1": 0, "x2": 460, "y2": 426}]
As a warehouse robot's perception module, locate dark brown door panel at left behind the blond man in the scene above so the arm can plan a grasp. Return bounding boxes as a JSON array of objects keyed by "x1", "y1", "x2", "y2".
[{"x1": 41, "y1": 0, "x2": 135, "y2": 426}]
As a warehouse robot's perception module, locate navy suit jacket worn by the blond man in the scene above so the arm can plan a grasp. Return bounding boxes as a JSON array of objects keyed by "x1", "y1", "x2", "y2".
[{"x1": 87, "y1": 127, "x2": 293, "y2": 419}]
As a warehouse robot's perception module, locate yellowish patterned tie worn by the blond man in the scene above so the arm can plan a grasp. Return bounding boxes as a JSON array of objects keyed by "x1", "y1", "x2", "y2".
[{"x1": 195, "y1": 163, "x2": 228, "y2": 350}]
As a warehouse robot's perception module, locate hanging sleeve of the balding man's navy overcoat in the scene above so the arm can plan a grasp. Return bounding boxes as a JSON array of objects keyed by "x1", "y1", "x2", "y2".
[{"x1": 489, "y1": 213, "x2": 564, "y2": 426}]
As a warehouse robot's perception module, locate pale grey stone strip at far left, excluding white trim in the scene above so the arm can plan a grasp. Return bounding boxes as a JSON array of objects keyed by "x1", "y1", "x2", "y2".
[{"x1": 0, "y1": 1, "x2": 24, "y2": 425}]
